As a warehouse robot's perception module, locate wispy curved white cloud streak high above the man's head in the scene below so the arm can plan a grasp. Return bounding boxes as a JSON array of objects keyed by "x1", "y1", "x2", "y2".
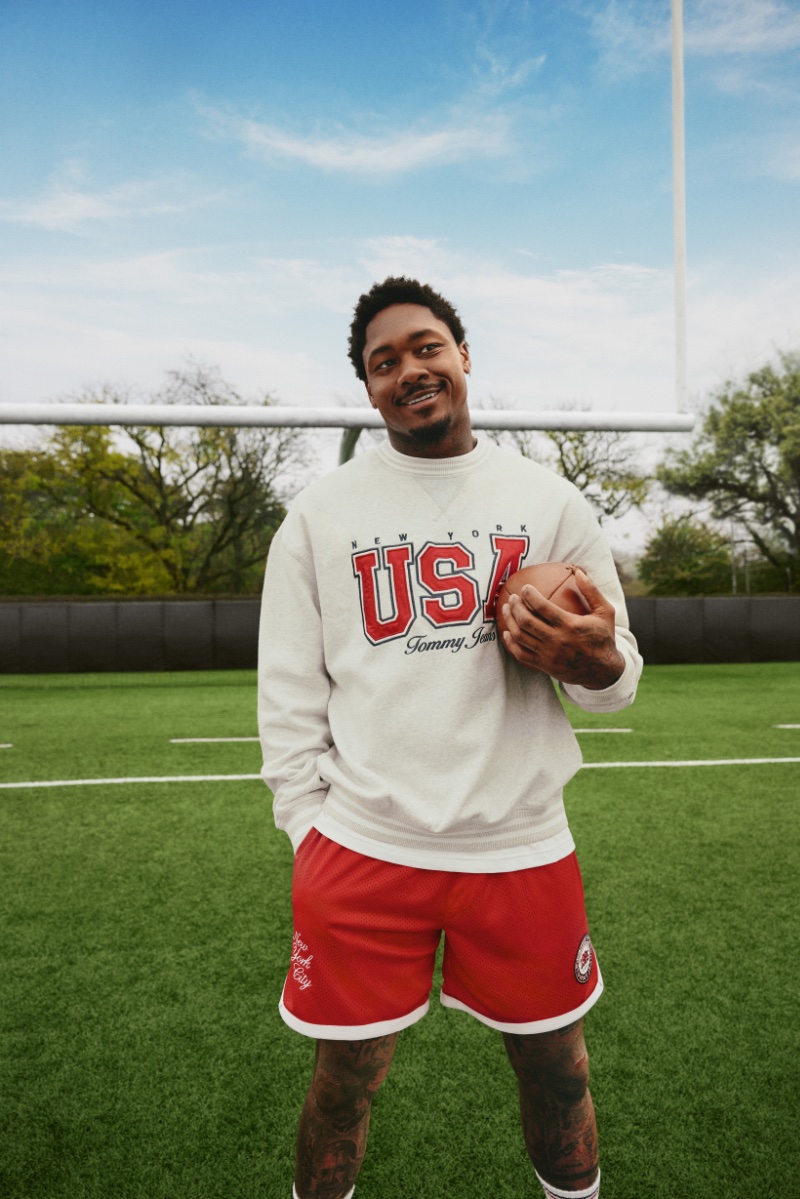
[{"x1": 203, "y1": 108, "x2": 510, "y2": 177}]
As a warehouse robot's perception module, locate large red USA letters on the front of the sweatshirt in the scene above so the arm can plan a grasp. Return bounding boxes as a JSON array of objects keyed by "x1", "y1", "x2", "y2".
[{"x1": 351, "y1": 532, "x2": 530, "y2": 645}]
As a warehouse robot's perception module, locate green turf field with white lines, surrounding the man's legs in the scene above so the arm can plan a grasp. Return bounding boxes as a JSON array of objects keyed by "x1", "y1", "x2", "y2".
[{"x1": 0, "y1": 663, "x2": 800, "y2": 1199}]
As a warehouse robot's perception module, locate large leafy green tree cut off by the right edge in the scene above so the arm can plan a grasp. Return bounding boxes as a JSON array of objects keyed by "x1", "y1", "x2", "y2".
[{"x1": 657, "y1": 354, "x2": 800, "y2": 589}]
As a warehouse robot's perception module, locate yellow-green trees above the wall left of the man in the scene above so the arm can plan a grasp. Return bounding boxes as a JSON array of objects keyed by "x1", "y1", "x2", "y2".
[{"x1": 0, "y1": 367, "x2": 306, "y2": 595}]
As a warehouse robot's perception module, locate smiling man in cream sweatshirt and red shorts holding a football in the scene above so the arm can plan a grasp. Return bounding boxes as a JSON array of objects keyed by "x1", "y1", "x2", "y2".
[{"x1": 259, "y1": 278, "x2": 642, "y2": 1199}]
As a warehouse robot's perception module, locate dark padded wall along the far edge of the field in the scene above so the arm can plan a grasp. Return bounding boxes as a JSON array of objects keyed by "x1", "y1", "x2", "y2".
[{"x1": 0, "y1": 596, "x2": 800, "y2": 674}]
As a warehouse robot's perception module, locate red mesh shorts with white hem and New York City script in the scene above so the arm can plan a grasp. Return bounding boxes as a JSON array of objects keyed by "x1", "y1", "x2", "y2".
[{"x1": 281, "y1": 829, "x2": 603, "y2": 1041}]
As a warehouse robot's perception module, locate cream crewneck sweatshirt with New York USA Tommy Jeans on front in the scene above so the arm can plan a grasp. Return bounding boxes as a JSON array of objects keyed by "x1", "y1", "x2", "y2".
[{"x1": 258, "y1": 439, "x2": 642, "y2": 873}]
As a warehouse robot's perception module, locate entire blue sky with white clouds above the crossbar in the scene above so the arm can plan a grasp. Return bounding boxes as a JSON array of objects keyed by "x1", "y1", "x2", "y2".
[{"x1": 0, "y1": 0, "x2": 800, "y2": 426}]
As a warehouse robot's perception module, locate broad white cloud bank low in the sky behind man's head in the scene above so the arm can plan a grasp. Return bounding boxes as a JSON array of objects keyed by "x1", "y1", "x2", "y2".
[{"x1": 0, "y1": 236, "x2": 800, "y2": 431}]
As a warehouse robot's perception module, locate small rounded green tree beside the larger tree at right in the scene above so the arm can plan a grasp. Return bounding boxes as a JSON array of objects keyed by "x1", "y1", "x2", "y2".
[{"x1": 637, "y1": 516, "x2": 730, "y2": 596}]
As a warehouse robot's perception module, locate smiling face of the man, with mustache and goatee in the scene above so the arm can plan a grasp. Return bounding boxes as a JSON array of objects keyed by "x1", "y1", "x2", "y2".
[{"x1": 363, "y1": 303, "x2": 474, "y2": 458}]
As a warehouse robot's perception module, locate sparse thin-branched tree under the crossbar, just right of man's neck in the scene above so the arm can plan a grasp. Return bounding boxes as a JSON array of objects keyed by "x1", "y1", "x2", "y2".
[{"x1": 488, "y1": 402, "x2": 650, "y2": 523}]
